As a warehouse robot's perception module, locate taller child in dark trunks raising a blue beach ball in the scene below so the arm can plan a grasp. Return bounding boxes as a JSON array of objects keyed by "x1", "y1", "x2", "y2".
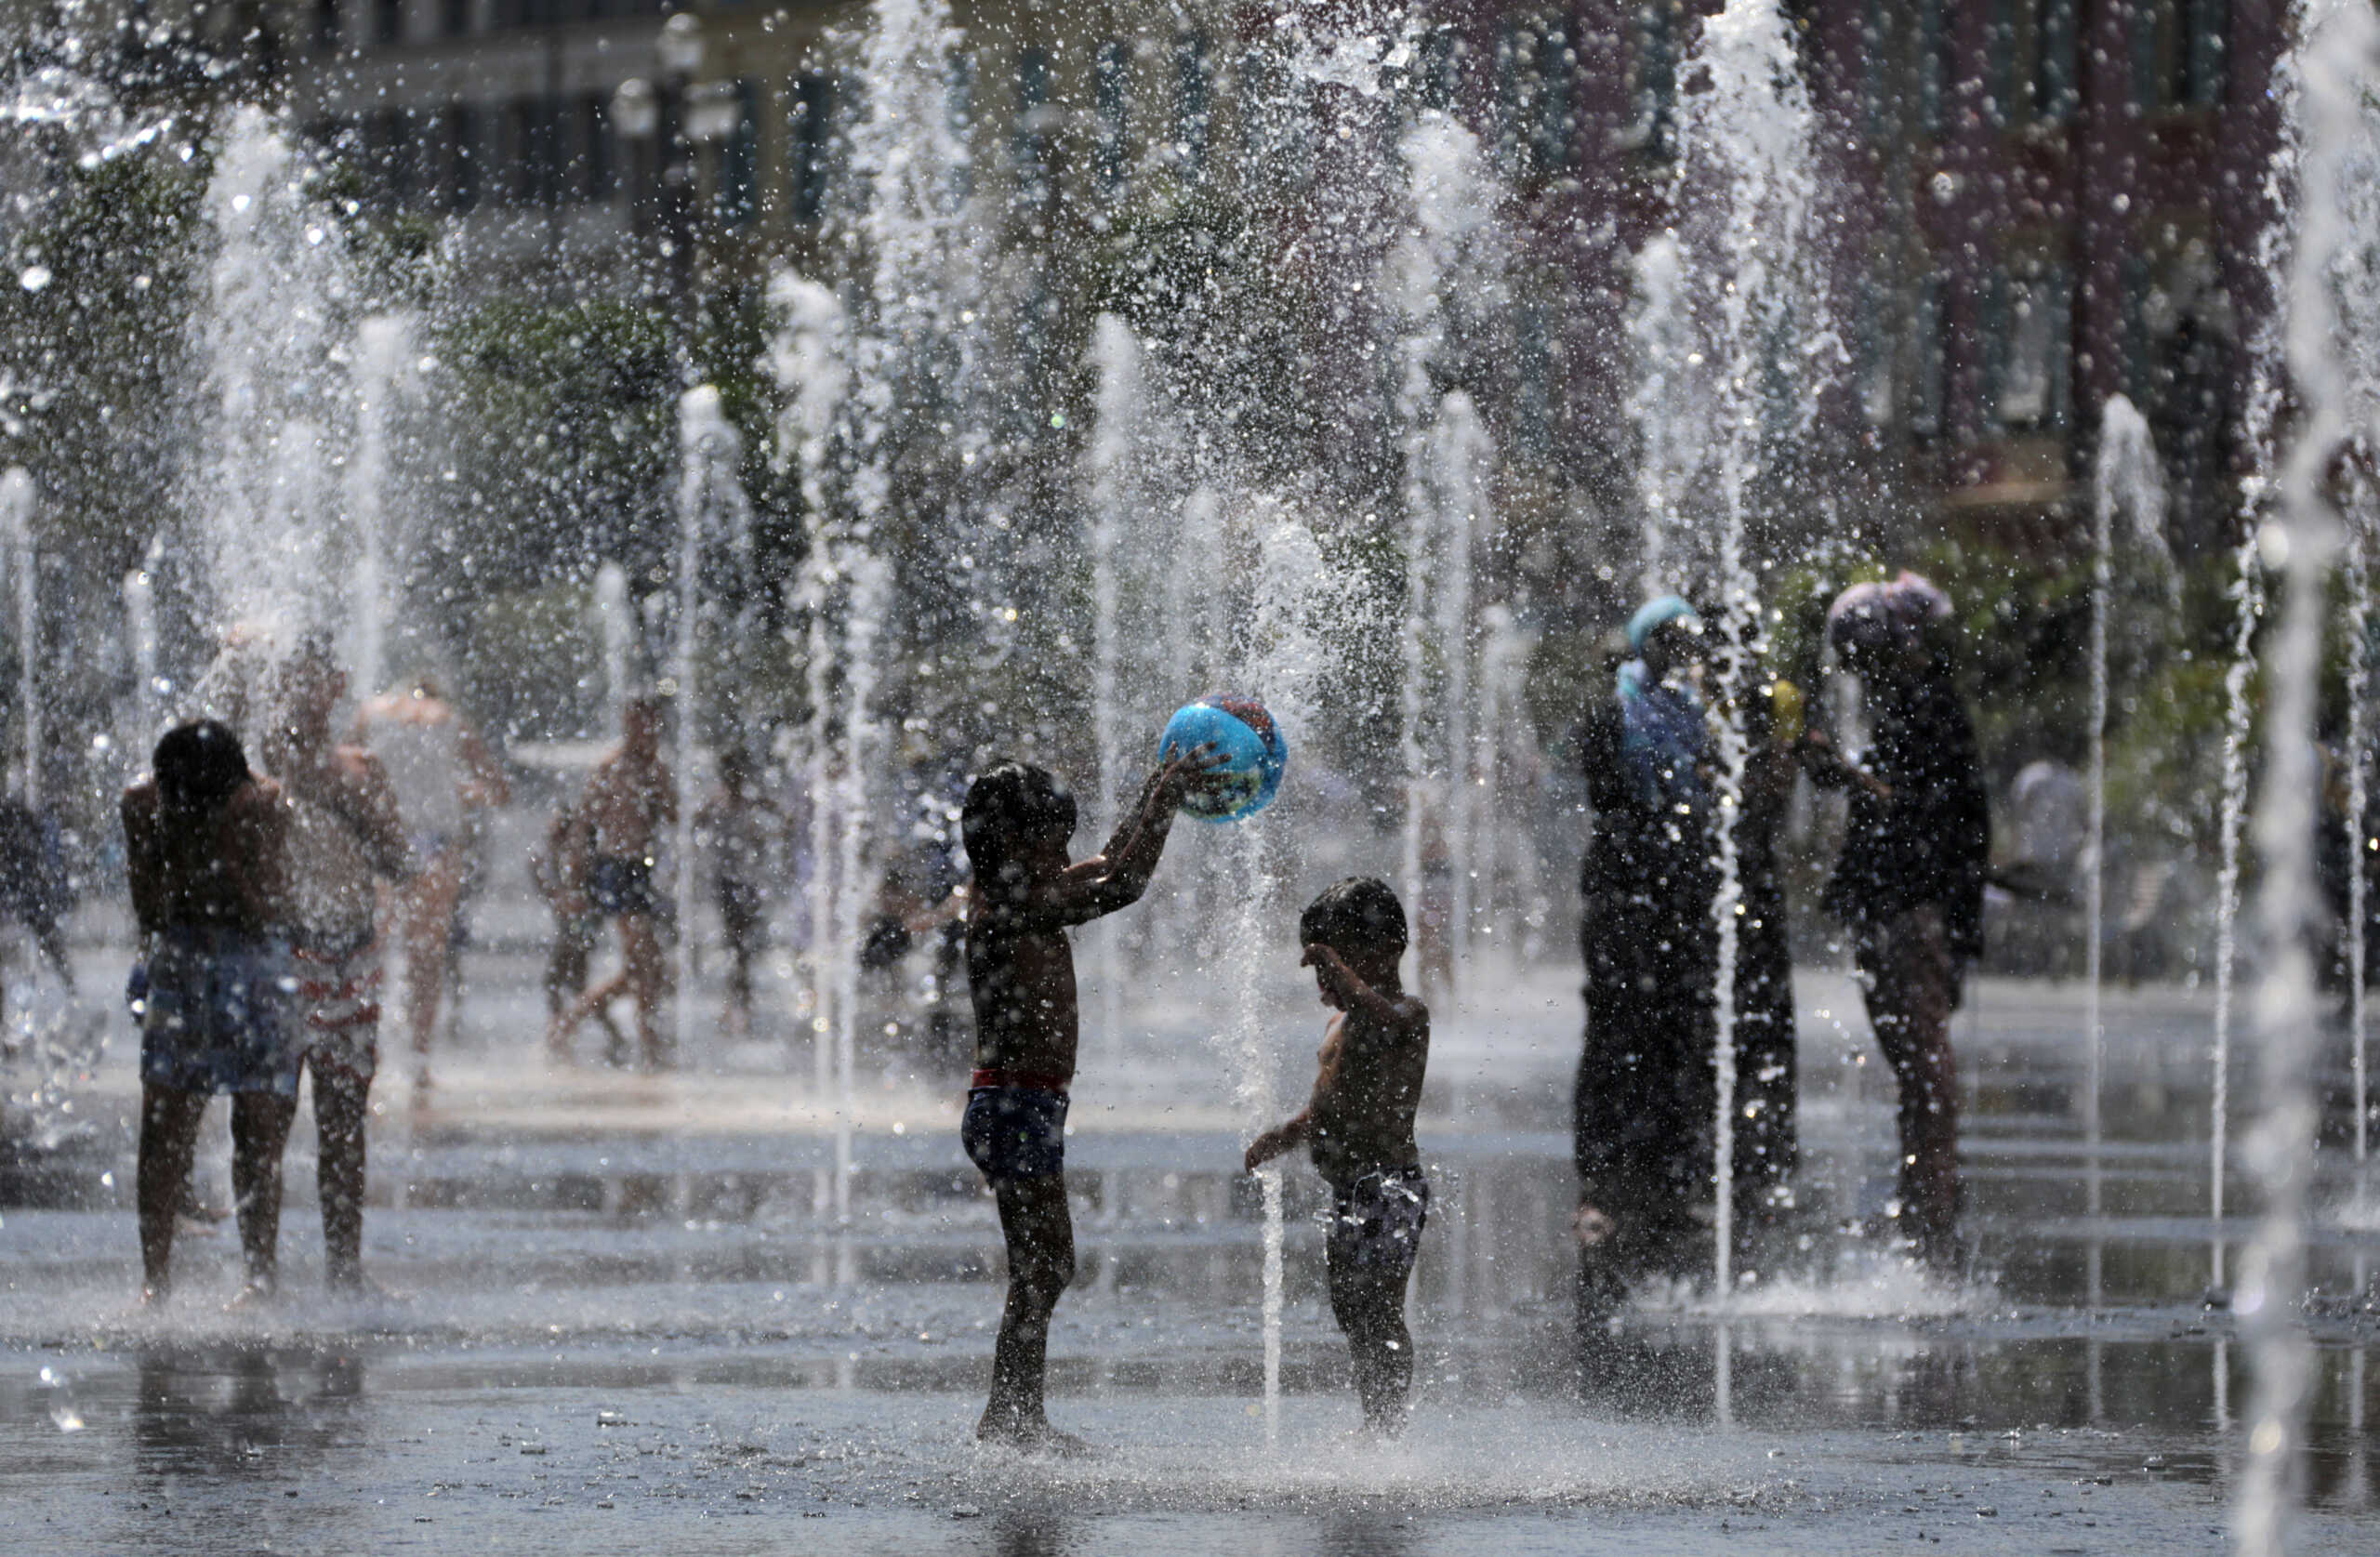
[{"x1": 959, "y1": 746, "x2": 1221, "y2": 1452}]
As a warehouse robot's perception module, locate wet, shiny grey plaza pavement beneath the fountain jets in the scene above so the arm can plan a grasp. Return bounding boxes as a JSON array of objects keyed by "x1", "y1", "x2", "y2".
[{"x1": 0, "y1": 961, "x2": 2380, "y2": 1554}]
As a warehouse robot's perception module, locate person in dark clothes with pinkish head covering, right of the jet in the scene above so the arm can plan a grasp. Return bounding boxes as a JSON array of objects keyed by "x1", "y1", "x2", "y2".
[{"x1": 1802, "y1": 572, "x2": 1992, "y2": 1272}]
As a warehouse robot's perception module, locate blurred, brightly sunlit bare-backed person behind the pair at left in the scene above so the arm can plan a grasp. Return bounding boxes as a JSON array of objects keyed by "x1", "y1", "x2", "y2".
[{"x1": 354, "y1": 676, "x2": 511, "y2": 1104}]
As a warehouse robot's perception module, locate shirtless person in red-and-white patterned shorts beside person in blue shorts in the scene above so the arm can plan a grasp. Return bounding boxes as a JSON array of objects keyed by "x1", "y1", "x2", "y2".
[{"x1": 264, "y1": 638, "x2": 412, "y2": 1293}]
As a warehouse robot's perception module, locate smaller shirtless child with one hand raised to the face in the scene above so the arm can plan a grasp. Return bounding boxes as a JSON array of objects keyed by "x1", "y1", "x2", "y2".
[{"x1": 1247, "y1": 877, "x2": 1431, "y2": 1435}]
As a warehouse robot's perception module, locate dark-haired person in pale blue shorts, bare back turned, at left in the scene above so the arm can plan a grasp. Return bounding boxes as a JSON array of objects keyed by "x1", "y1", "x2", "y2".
[{"x1": 124, "y1": 719, "x2": 305, "y2": 1302}]
